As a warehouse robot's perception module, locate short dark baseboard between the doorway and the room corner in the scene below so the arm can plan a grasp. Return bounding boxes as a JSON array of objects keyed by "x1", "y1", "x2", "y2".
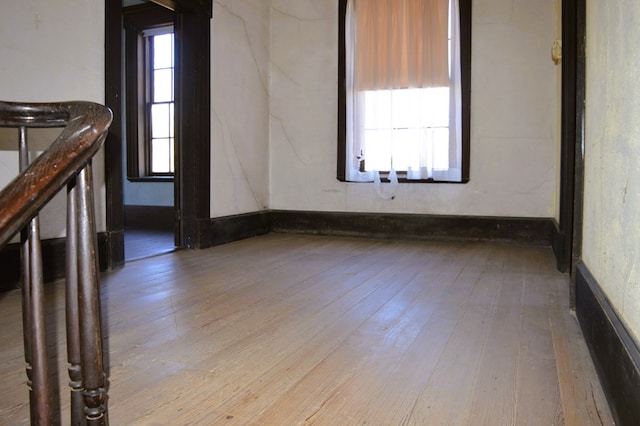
[{"x1": 210, "y1": 210, "x2": 271, "y2": 246}]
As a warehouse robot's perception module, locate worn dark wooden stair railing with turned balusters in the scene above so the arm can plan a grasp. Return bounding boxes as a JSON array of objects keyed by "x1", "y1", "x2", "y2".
[{"x1": 0, "y1": 101, "x2": 112, "y2": 425}]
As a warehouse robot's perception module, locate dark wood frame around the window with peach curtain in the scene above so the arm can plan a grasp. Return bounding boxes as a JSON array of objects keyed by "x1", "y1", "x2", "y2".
[{"x1": 337, "y1": 0, "x2": 471, "y2": 183}]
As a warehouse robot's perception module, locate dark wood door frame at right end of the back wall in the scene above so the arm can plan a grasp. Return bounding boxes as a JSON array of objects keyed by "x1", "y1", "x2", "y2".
[{"x1": 553, "y1": 0, "x2": 586, "y2": 304}]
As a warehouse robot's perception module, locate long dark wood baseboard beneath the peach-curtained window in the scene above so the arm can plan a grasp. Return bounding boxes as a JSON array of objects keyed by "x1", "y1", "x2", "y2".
[{"x1": 271, "y1": 210, "x2": 553, "y2": 246}]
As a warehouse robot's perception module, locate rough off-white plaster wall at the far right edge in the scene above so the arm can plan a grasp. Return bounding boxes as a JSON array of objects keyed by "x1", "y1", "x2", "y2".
[{"x1": 583, "y1": 0, "x2": 640, "y2": 339}]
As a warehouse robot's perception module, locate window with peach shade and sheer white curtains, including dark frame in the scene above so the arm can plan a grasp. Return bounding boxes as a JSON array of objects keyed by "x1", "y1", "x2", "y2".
[{"x1": 338, "y1": 0, "x2": 471, "y2": 182}]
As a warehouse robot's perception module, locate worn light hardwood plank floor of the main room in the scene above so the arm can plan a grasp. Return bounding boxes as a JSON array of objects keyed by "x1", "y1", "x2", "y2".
[{"x1": 0, "y1": 234, "x2": 613, "y2": 425}]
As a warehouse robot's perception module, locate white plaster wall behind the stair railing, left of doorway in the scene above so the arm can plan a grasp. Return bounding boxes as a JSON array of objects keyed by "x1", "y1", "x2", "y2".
[{"x1": 0, "y1": 0, "x2": 105, "y2": 238}]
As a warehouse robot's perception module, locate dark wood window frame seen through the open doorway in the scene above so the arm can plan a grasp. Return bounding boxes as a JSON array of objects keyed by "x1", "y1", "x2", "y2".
[{"x1": 123, "y1": 3, "x2": 178, "y2": 182}]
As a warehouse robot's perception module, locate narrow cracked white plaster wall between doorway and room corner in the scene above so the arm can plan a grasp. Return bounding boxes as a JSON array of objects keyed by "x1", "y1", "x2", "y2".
[{"x1": 211, "y1": 0, "x2": 270, "y2": 217}]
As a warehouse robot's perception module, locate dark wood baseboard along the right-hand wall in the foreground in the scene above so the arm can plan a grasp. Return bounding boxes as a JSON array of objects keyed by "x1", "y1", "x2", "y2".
[{"x1": 576, "y1": 263, "x2": 640, "y2": 425}]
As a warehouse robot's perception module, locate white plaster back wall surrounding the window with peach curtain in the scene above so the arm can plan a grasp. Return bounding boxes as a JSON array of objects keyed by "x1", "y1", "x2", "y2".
[{"x1": 268, "y1": 0, "x2": 558, "y2": 217}]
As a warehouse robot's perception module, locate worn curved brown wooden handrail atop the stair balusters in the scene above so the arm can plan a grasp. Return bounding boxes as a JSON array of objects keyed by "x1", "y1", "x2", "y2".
[{"x1": 0, "y1": 101, "x2": 112, "y2": 248}]
